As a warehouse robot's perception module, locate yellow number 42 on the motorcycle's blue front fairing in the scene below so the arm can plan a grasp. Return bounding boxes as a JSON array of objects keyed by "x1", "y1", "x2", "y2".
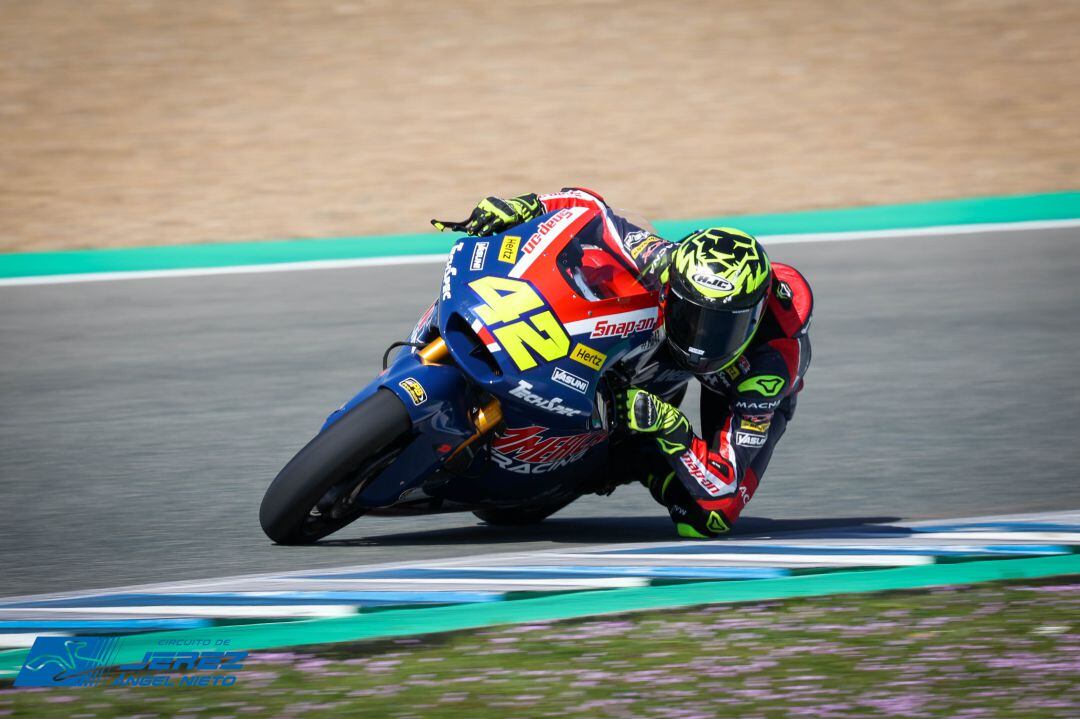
[{"x1": 469, "y1": 276, "x2": 570, "y2": 371}]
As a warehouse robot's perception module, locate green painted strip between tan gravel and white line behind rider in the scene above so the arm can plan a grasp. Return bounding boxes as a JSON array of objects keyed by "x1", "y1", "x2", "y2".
[{"x1": 0, "y1": 191, "x2": 1080, "y2": 279}]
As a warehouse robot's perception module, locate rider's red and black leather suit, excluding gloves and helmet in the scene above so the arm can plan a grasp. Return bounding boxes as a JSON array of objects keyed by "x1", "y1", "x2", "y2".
[{"x1": 540, "y1": 189, "x2": 813, "y2": 534}]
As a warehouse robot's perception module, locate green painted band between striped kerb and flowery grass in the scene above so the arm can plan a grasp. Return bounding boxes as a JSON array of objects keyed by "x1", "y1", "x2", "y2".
[{"x1": 0, "y1": 554, "x2": 1080, "y2": 677}]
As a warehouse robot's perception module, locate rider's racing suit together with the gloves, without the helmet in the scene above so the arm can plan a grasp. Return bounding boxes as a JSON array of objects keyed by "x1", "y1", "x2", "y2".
[{"x1": 436, "y1": 188, "x2": 813, "y2": 538}]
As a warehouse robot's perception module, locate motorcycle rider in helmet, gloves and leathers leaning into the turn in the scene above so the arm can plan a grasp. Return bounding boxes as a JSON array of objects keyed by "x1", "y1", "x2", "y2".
[{"x1": 432, "y1": 188, "x2": 813, "y2": 539}]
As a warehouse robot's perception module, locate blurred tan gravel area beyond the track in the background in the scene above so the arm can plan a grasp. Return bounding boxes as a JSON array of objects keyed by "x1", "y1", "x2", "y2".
[{"x1": 0, "y1": 0, "x2": 1080, "y2": 252}]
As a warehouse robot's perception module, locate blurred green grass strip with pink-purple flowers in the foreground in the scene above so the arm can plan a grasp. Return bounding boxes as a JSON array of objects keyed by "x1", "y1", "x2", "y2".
[{"x1": 0, "y1": 576, "x2": 1080, "y2": 719}]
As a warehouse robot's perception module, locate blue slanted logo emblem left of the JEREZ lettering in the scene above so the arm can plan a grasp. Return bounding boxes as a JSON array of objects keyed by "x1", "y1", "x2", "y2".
[{"x1": 15, "y1": 637, "x2": 118, "y2": 687}]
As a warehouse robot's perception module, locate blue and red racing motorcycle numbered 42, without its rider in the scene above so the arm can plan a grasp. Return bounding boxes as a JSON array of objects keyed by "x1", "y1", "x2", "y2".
[{"x1": 259, "y1": 208, "x2": 660, "y2": 544}]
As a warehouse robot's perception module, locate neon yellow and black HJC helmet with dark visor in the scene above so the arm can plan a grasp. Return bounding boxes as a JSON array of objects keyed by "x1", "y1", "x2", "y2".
[{"x1": 664, "y1": 227, "x2": 772, "y2": 375}]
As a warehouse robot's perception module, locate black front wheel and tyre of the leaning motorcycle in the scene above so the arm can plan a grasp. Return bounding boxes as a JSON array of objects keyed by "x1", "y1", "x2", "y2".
[{"x1": 259, "y1": 389, "x2": 411, "y2": 544}]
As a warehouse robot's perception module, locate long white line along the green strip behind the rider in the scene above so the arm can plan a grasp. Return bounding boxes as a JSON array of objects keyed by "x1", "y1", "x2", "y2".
[{"x1": 0, "y1": 218, "x2": 1080, "y2": 287}]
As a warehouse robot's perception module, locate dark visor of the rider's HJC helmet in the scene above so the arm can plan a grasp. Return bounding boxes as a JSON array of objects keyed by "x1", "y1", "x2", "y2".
[{"x1": 664, "y1": 286, "x2": 765, "y2": 374}]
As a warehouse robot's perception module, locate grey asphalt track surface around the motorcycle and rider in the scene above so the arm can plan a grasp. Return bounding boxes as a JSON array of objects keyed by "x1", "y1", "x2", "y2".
[{"x1": 0, "y1": 229, "x2": 1080, "y2": 595}]
